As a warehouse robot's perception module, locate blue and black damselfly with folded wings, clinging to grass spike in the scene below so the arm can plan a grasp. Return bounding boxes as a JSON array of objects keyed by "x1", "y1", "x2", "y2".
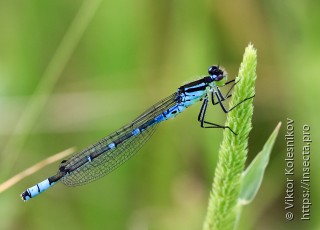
[{"x1": 21, "y1": 66, "x2": 253, "y2": 201}]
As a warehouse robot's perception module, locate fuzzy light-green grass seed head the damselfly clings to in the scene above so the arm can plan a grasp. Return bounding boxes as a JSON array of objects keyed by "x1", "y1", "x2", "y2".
[{"x1": 203, "y1": 44, "x2": 257, "y2": 230}]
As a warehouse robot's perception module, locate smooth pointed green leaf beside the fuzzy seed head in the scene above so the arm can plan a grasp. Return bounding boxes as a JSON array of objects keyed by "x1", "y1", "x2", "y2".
[{"x1": 238, "y1": 122, "x2": 281, "y2": 205}]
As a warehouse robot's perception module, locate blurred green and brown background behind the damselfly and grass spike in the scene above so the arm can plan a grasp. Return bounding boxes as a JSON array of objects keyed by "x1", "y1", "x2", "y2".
[{"x1": 0, "y1": 0, "x2": 320, "y2": 230}]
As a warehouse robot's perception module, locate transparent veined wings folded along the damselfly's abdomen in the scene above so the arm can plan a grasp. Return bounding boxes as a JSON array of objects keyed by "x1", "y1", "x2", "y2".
[{"x1": 60, "y1": 93, "x2": 176, "y2": 186}]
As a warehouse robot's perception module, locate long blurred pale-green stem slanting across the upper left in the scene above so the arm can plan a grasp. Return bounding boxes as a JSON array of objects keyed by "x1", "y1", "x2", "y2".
[{"x1": 1, "y1": 0, "x2": 101, "y2": 180}]
